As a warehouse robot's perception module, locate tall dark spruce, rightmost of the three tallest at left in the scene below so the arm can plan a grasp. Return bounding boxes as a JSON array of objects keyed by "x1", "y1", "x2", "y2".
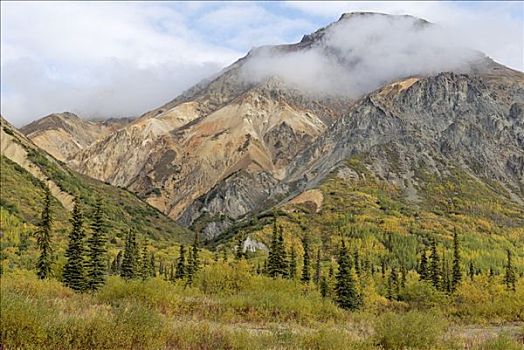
[{"x1": 86, "y1": 200, "x2": 107, "y2": 290}]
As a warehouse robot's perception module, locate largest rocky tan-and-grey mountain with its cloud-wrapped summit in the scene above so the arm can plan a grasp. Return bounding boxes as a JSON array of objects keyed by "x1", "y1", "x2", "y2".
[{"x1": 20, "y1": 13, "x2": 524, "y2": 238}]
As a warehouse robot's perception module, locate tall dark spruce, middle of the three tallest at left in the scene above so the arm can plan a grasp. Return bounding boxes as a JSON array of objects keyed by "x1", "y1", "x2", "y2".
[{"x1": 62, "y1": 199, "x2": 87, "y2": 291}]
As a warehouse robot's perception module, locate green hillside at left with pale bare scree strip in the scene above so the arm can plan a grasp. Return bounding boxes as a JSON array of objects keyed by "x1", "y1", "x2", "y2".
[{"x1": 0, "y1": 118, "x2": 192, "y2": 241}]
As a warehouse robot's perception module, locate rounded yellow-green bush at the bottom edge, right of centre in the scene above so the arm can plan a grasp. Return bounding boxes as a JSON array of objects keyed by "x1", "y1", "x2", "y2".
[{"x1": 375, "y1": 311, "x2": 446, "y2": 349}]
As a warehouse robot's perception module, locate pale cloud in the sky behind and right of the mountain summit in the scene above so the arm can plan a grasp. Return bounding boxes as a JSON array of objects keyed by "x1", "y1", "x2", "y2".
[{"x1": 285, "y1": 1, "x2": 524, "y2": 71}]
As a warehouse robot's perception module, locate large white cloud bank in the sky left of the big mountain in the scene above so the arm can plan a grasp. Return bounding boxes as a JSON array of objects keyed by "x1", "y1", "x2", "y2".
[{"x1": 1, "y1": 2, "x2": 242, "y2": 126}]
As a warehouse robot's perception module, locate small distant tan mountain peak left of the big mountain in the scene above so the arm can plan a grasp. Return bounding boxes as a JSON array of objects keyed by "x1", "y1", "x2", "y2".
[{"x1": 20, "y1": 112, "x2": 130, "y2": 161}]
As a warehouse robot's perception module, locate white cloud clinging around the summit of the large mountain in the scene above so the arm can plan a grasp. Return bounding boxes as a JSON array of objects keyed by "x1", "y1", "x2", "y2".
[{"x1": 242, "y1": 14, "x2": 484, "y2": 98}]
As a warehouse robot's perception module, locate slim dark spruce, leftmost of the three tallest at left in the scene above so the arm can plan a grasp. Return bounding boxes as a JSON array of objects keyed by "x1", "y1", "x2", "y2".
[{"x1": 36, "y1": 186, "x2": 53, "y2": 279}]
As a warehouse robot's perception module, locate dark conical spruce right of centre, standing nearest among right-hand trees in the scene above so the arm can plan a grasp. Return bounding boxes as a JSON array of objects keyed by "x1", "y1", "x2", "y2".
[{"x1": 336, "y1": 241, "x2": 360, "y2": 310}]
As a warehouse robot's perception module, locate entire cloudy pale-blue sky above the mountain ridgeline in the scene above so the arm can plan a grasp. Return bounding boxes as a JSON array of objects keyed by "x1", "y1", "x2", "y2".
[{"x1": 0, "y1": 1, "x2": 524, "y2": 127}]
